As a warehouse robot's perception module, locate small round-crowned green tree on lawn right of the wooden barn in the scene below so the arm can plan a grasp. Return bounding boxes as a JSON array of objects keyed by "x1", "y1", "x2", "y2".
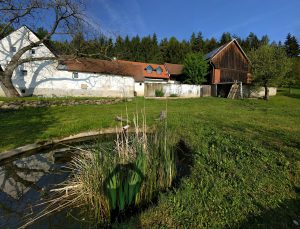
[{"x1": 249, "y1": 45, "x2": 291, "y2": 100}]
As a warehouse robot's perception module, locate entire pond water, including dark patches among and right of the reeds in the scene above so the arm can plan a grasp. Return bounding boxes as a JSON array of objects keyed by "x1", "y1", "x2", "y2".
[{"x1": 0, "y1": 134, "x2": 192, "y2": 228}]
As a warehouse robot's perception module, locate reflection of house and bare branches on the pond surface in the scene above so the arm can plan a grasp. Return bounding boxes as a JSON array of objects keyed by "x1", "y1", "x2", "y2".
[{"x1": 0, "y1": 148, "x2": 68, "y2": 228}]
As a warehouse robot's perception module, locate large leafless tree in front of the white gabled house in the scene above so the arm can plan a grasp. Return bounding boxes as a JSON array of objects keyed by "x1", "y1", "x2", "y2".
[{"x1": 0, "y1": 0, "x2": 85, "y2": 97}]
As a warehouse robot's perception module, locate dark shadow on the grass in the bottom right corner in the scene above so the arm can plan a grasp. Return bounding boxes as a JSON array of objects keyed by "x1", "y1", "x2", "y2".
[{"x1": 235, "y1": 198, "x2": 300, "y2": 229}]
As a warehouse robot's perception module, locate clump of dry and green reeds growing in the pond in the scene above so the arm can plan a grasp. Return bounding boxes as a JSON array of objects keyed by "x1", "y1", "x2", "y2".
[{"x1": 24, "y1": 113, "x2": 176, "y2": 224}]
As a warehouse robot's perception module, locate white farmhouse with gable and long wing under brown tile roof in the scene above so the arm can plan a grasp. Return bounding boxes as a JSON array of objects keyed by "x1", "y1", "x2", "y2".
[{"x1": 0, "y1": 26, "x2": 138, "y2": 97}]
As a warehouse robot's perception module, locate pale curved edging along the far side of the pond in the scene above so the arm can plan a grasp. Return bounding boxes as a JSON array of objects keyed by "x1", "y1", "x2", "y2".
[{"x1": 0, "y1": 128, "x2": 144, "y2": 162}]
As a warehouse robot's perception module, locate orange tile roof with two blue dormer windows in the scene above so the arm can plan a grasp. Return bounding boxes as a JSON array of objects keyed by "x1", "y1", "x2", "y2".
[{"x1": 118, "y1": 60, "x2": 169, "y2": 79}]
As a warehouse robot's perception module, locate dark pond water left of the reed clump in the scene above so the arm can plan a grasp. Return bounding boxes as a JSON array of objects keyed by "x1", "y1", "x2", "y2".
[{"x1": 0, "y1": 136, "x2": 112, "y2": 228}]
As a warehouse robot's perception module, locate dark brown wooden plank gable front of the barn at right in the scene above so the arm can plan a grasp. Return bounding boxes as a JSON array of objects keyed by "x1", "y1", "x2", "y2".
[{"x1": 207, "y1": 40, "x2": 252, "y2": 84}]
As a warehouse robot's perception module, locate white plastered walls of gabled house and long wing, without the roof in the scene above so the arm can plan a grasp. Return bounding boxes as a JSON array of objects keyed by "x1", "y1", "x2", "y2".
[{"x1": 0, "y1": 27, "x2": 135, "y2": 97}]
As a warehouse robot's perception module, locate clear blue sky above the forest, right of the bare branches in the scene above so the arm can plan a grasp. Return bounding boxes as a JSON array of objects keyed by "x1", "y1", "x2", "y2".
[{"x1": 87, "y1": 0, "x2": 300, "y2": 41}]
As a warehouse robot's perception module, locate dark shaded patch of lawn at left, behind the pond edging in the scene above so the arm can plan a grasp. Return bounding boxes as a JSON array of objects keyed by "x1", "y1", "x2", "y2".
[{"x1": 0, "y1": 108, "x2": 56, "y2": 152}]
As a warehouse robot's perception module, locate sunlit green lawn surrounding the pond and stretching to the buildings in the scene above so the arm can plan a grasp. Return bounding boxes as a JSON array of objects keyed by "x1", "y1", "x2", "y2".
[{"x1": 0, "y1": 89, "x2": 300, "y2": 228}]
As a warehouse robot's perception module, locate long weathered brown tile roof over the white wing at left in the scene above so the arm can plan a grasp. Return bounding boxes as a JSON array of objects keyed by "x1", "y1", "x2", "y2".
[{"x1": 61, "y1": 57, "x2": 144, "y2": 81}]
